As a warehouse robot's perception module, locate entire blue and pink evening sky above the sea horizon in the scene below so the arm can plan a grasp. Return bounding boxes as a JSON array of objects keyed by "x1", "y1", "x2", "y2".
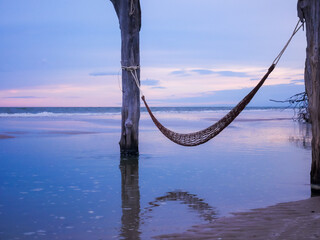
[{"x1": 0, "y1": 0, "x2": 306, "y2": 107}]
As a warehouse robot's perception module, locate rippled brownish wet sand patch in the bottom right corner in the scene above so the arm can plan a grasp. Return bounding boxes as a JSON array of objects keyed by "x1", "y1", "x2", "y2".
[{"x1": 156, "y1": 197, "x2": 320, "y2": 240}]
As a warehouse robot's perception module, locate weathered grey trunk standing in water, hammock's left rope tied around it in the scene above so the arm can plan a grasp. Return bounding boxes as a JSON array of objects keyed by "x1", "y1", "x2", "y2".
[{"x1": 111, "y1": 0, "x2": 141, "y2": 155}]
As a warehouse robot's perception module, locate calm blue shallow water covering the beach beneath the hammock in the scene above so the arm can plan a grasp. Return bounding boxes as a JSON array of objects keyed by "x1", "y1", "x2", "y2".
[{"x1": 0, "y1": 109, "x2": 311, "y2": 239}]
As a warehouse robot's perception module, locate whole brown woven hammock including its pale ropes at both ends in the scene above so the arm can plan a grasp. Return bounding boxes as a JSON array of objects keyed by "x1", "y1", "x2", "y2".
[{"x1": 122, "y1": 20, "x2": 303, "y2": 146}]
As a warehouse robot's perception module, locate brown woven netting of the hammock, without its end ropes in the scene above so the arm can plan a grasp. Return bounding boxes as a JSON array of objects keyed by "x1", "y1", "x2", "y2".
[{"x1": 141, "y1": 64, "x2": 275, "y2": 147}]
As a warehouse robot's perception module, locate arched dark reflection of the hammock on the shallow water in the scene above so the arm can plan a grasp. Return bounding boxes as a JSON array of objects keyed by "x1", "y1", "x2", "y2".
[{"x1": 141, "y1": 191, "x2": 217, "y2": 222}]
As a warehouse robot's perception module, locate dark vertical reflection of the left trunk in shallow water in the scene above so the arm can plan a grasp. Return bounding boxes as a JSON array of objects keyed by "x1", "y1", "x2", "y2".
[{"x1": 120, "y1": 158, "x2": 140, "y2": 240}]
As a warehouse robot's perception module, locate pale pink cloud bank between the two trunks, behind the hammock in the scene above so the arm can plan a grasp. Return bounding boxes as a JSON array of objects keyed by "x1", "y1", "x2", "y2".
[{"x1": 142, "y1": 65, "x2": 303, "y2": 106}]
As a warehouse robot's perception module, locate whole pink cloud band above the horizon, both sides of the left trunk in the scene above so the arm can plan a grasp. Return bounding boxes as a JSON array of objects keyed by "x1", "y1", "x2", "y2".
[{"x1": 0, "y1": 65, "x2": 304, "y2": 106}]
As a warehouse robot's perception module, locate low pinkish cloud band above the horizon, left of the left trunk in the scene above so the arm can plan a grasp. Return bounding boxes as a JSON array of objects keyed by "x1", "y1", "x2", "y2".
[{"x1": 0, "y1": 80, "x2": 121, "y2": 107}]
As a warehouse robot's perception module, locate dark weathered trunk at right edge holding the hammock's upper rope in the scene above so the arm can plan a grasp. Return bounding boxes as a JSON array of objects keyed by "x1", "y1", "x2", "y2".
[{"x1": 298, "y1": 0, "x2": 320, "y2": 192}]
